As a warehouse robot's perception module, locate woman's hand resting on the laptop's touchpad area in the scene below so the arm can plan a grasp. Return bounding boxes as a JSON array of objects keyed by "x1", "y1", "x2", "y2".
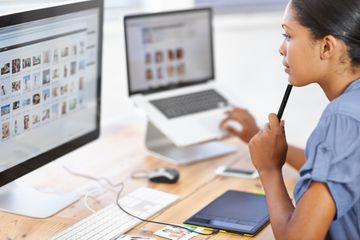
[{"x1": 220, "y1": 108, "x2": 260, "y2": 143}]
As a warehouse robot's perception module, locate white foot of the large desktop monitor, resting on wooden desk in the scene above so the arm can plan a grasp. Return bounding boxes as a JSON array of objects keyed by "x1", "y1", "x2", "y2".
[{"x1": 0, "y1": 182, "x2": 80, "y2": 218}]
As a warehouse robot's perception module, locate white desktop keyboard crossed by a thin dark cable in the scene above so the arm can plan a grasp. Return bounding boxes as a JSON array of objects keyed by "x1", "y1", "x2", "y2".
[{"x1": 50, "y1": 187, "x2": 179, "y2": 240}]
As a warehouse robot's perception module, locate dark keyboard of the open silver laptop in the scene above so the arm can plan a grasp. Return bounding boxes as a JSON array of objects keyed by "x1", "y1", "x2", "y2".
[{"x1": 150, "y1": 90, "x2": 229, "y2": 119}]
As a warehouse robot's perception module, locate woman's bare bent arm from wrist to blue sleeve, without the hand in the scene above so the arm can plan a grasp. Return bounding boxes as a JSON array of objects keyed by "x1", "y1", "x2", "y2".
[{"x1": 260, "y1": 171, "x2": 336, "y2": 240}]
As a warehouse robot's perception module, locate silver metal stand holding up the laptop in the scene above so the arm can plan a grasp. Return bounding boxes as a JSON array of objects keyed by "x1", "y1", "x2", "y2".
[{"x1": 145, "y1": 121, "x2": 237, "y2": 164}]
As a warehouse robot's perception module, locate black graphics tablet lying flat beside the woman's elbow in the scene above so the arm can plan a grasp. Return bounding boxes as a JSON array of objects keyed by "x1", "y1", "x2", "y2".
[{"x1": 184, "y1": 190, "x2": 269, "y2": 235}]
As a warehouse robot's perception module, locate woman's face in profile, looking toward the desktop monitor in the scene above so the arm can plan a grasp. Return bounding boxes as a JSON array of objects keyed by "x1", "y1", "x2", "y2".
[{"x1": 279, "y1": 4, "x2": 322, "y2": 86}]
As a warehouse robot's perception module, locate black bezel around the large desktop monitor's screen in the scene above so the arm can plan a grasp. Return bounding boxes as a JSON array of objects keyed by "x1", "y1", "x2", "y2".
[{"x1": 0, "y1": 0, "x2": 104, "y2": 187}]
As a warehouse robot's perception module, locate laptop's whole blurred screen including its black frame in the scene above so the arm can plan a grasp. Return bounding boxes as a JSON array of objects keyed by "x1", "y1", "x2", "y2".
[{"x1": 124, "y1": 8, "x2": 214, "y2": 95}]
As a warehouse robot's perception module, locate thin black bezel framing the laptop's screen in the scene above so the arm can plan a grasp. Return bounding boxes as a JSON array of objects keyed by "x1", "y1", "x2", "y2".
[{"x1": 124, "y1": 7, "x2": 215, "y2": 96}]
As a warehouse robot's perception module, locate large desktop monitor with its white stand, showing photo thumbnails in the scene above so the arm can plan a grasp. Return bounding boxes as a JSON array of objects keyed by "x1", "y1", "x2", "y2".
[{"x1": 0, "y1": 0, "x2": 103, "y2": 217}]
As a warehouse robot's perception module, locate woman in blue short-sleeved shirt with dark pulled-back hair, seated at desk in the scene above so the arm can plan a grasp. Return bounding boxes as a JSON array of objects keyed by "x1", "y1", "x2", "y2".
[{"x1": 221, "y1": 0, "x2": 360, "y2": 240}]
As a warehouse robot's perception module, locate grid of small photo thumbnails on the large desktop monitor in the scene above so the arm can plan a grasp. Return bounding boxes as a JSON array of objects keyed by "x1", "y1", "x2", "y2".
[{"x1": 0, "y1": 39, "x2": 86, "y2": 141}]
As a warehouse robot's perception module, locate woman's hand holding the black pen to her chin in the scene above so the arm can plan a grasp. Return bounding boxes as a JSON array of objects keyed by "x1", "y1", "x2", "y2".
[{"x1": 249, "y1": 113, "x2": 288, "y2": 175}]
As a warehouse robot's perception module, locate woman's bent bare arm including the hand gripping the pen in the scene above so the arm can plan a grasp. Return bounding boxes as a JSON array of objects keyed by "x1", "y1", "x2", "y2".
[{"x1": 249, "y1": 114, "x2": 336, "y2": 240}]
